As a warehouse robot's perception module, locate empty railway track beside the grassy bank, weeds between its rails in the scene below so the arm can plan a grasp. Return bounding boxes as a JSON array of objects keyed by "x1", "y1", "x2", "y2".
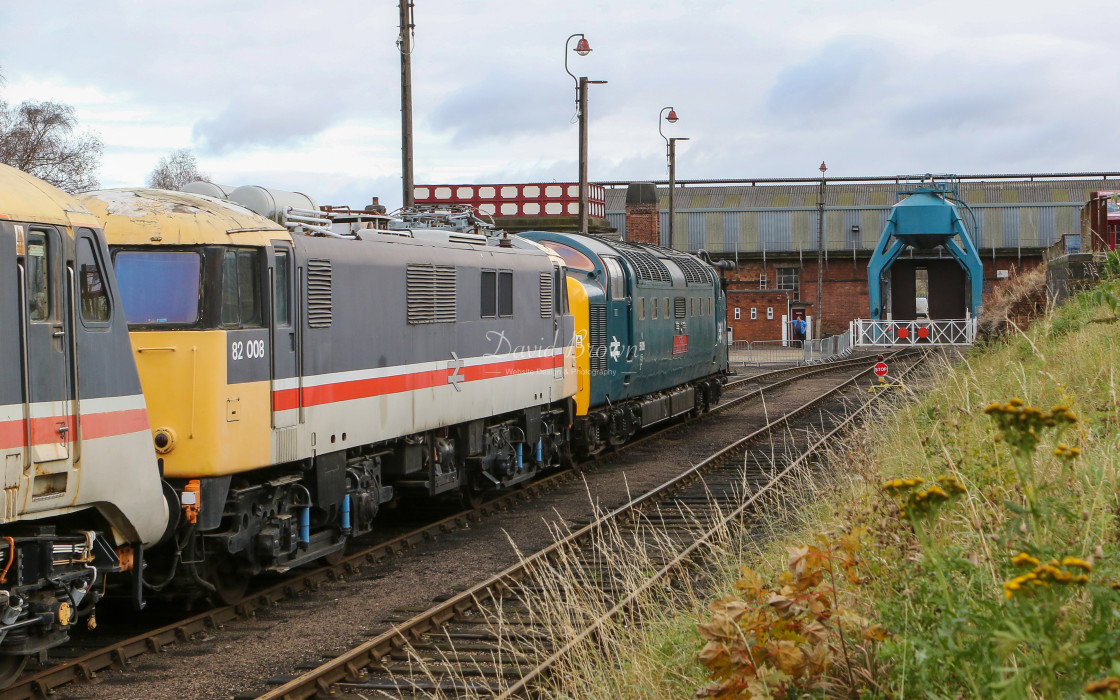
[{"x1": 260, "y1": 351, "x2": 918, "y2": 700}]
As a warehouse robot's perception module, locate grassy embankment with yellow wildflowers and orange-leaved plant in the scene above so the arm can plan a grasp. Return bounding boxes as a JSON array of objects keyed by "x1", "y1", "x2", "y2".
[{"x1": 526, "y1": 269, "x2": 1120, "y2": 698}]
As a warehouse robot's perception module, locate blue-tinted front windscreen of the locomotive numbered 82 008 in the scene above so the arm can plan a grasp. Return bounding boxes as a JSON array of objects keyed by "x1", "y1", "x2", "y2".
[{"x1": 113, "y1": 250, "x2": 202, "y2": 325}]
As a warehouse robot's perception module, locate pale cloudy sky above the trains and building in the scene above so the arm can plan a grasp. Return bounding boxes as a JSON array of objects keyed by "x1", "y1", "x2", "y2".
[{"x1": 0, "y1": 0, "x2": 1120, "y2": 207}]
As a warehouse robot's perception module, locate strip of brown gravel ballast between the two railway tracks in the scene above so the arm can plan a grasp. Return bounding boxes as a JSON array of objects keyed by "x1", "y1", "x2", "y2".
[{"x1": 55, "y1": 374, "x2": 864, "y2": 700}]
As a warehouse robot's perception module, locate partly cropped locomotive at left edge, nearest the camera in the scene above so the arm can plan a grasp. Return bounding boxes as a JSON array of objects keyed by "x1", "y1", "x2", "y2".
[{"x1": 0, "y1": 165, "x2": 168, "y2": 688}]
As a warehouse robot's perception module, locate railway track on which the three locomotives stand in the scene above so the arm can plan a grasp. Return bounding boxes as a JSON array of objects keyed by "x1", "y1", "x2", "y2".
[{"x1": 0, "y1": 357, "x2": 904, "y2": 700}]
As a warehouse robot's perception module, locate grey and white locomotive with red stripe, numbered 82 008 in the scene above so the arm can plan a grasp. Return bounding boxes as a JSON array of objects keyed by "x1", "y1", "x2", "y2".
[{"x1": 82, "y1": 188, "x2": 576, "y2": 600}]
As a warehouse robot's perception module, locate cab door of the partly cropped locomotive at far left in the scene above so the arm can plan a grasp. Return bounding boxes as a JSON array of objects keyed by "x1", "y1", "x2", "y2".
[{"x1": 17, "y1": 226, "x2": 76, "y2": 470}]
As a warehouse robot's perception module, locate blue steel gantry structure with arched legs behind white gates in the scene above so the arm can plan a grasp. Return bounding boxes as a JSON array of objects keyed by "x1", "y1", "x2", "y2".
[{"x1": 867, "y1": 176, "x2": 983, "y2": 320}]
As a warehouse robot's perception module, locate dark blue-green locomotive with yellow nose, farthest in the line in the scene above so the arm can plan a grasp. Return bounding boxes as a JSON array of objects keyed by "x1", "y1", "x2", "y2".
[{"x1": 521, "y1": 231, "x2": 727, "y2": 455}]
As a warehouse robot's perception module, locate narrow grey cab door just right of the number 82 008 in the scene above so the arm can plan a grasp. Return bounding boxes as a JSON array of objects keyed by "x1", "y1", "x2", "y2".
[{"x1": 269, "y1": 243, "x2": 299, "y2": 428}]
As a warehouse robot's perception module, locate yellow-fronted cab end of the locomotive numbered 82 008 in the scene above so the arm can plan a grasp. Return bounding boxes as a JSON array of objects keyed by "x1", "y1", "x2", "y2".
[{"x1": 82, "y1": 189, "x2": 291, "y2": 479}]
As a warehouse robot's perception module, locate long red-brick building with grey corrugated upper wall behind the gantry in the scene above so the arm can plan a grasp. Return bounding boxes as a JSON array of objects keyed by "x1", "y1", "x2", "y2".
[{"x1": 605, "y1": 174, "x2": 1120, "y2": 340}]
